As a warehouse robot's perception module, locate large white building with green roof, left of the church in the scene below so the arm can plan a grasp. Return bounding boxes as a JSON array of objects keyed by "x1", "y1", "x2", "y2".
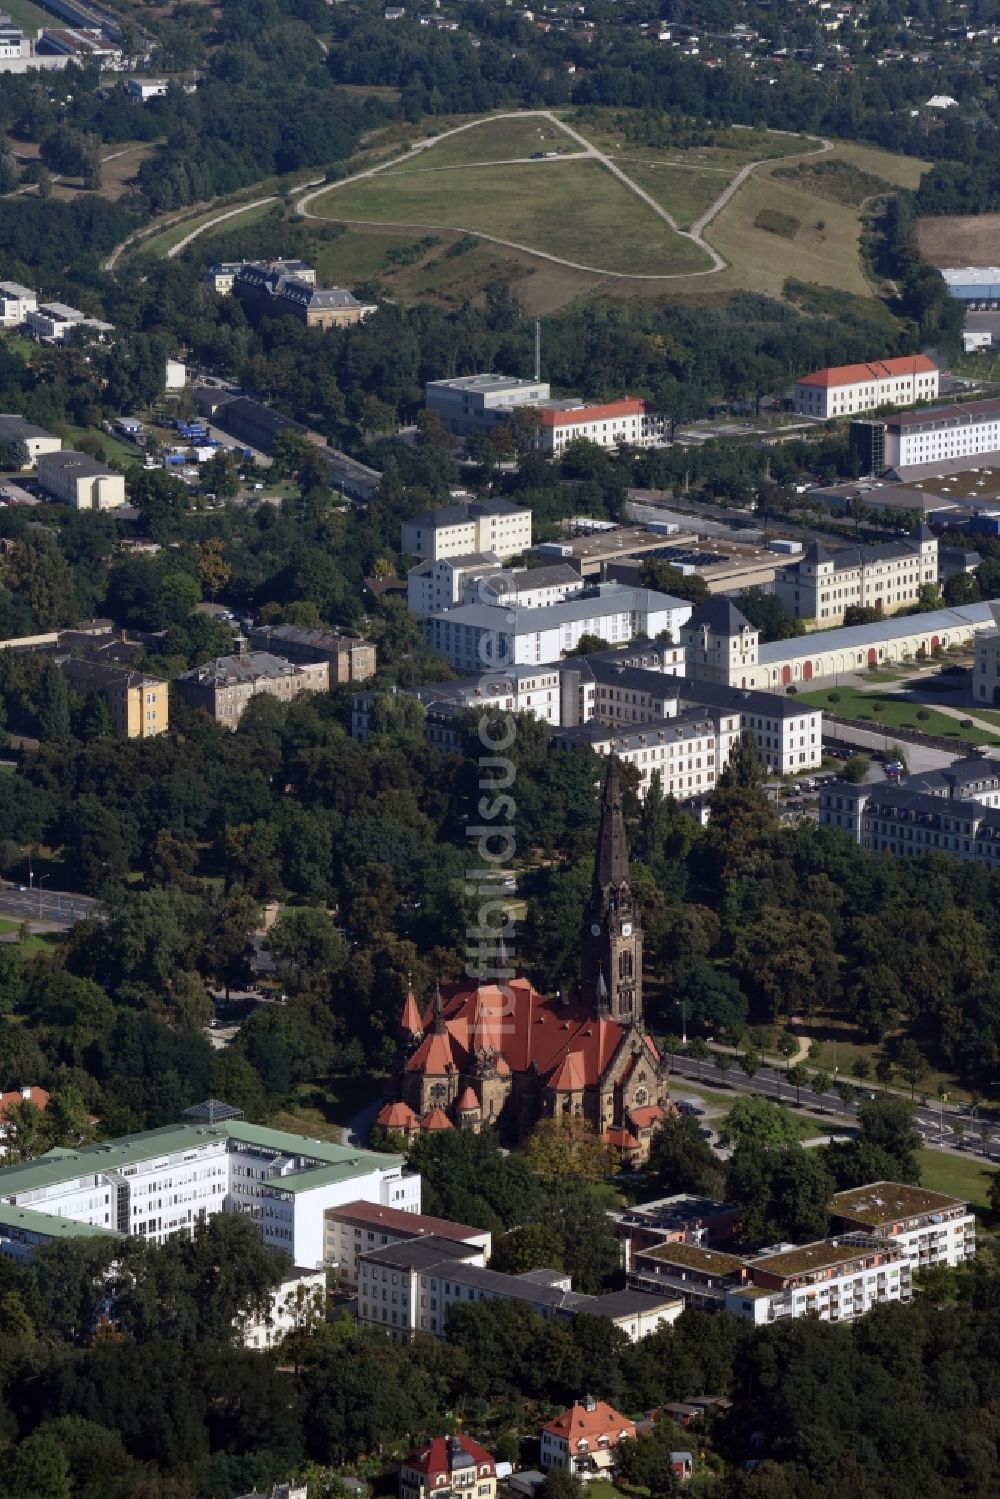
[{"x1": 0, "y1": 1102, "x2": 420, "y2": 1268}]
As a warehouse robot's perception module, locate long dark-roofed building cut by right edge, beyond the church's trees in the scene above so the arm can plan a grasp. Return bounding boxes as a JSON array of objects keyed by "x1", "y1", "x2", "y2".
[{"x1": 820, "y1": 755, "x2": 1000, "y2": 869}]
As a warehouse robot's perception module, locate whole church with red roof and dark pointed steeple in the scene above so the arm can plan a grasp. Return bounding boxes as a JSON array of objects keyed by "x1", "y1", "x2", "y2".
[{"x1": 376, "y1": 755, "x2": 670, "y2": 1165}]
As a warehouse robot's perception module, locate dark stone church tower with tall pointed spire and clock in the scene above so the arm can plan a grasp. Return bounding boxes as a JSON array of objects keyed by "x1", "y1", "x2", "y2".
[{"x1": 580, "y1": 755, "x2": 642, "y2": 1025}]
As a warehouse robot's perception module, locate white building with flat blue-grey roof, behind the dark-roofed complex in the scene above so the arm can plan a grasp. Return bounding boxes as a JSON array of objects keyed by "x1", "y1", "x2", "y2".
[{"x1": 424, "y1": 583, "x2": 691, "y2": 672}]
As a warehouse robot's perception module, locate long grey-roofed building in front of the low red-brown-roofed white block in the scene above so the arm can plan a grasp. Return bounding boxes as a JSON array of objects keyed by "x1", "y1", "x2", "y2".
[{"x1": 357, "y1": 1235, "x2": 682, "y2": 1342}]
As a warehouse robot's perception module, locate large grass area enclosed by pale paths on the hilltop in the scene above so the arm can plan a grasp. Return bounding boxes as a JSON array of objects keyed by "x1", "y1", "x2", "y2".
[{"x1": 312, "y1": 151, "x2": 708, "y2": 276}]
